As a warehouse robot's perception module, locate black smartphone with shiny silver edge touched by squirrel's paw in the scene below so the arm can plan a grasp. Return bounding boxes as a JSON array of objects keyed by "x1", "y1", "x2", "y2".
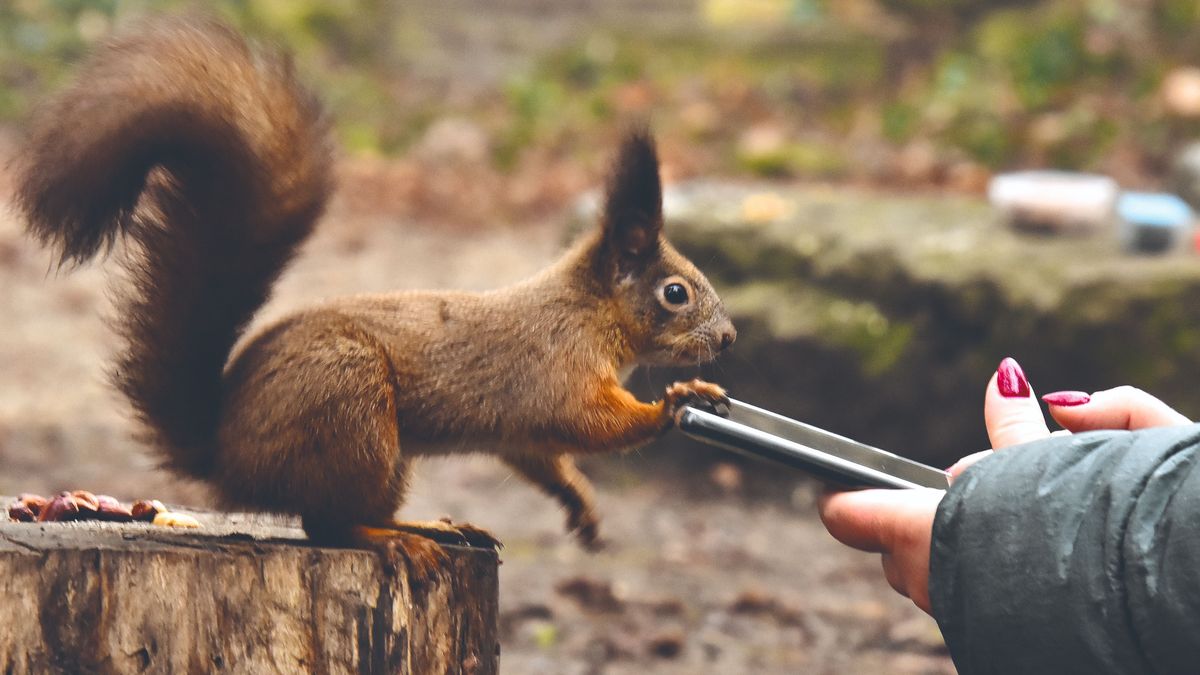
[{"x1": 679, "y1": 399, "x2": 950, "y2": 490}]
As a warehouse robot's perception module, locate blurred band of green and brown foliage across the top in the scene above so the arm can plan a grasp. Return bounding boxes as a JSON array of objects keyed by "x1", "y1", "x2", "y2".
[{"x1": 0, "y1": 0, "x2": 1200, "y2": 178}]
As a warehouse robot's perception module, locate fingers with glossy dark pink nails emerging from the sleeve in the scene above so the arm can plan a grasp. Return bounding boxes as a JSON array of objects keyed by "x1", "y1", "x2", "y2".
[{"x1": 820, "y1": 359, "x2": 1189, "y2": 613}]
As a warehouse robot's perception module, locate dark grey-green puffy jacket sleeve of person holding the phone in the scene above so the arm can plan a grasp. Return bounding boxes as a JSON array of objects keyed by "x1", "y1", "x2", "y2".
[{"x1": 930, "y1": 425, "x2": 1200, "y2": 675}]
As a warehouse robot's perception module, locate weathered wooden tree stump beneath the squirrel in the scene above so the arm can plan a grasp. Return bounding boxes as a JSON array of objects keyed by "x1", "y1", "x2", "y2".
[{"x1": 0, "y1": 500, "x2": 499, "y2": 675}]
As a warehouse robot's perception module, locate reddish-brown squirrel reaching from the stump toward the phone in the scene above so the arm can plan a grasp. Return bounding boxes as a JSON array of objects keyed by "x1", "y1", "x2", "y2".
[{"x1": 14, "y1": 17, "x2": 736, "y2": 574}]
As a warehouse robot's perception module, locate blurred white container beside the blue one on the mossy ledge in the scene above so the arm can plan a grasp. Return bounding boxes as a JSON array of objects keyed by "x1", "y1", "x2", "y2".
[{"x1": 988, "y1": 171, "x2": 1120, "y2": 232}]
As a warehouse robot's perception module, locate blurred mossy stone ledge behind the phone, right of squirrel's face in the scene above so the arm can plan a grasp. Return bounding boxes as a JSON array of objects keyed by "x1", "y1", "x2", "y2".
[{"x1": 635, "y1": 183, "x2": 1200, "y2": 464}]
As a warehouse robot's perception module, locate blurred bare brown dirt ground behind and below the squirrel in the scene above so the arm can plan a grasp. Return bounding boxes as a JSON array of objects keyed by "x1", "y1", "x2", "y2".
[{"x1": 0, "y1": 153, "x2": 953, "y2": 674}]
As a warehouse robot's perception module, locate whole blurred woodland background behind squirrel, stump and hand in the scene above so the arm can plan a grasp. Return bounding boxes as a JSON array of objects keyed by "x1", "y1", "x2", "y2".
[{"x1": 0, "y1": 0, "x2": 1200, "y2": 673}]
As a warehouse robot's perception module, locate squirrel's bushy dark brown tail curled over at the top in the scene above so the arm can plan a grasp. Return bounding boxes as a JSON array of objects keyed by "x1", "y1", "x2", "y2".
[{"x1": 14, "y1": 17, "x2": 332, "y2": 477}]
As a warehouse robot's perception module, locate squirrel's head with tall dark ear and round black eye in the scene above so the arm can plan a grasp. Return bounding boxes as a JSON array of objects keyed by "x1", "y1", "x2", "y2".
[{"x1": 594, "y1": 130, "x2": 737, "y2": 366}]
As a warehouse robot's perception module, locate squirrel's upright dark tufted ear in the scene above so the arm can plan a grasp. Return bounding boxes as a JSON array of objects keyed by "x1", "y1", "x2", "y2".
[{"x1": 601, "y1": 129, "x2": 662, "y2": 259}]
